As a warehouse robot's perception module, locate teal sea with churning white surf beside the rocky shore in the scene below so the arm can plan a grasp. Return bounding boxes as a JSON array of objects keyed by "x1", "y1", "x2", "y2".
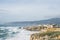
[{"x1": 0, "y1": 27, "x2": 39, "y2": 40}]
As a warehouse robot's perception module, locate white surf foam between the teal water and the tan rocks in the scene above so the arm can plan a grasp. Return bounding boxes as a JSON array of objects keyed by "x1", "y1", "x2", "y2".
[{"x1": 0, "y1": 27, "x2": 39, "y2": 40}]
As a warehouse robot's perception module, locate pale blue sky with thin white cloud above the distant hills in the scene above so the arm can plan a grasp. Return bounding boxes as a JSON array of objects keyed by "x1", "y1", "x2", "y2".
[{"x1": 0, "y1": 0, "x2": 60, "y2": 23}]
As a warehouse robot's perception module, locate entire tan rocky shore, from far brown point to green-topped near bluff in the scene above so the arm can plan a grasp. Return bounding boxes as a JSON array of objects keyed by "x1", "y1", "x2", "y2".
[{"x1": 25, "y1": 25, "x2": 60, "y2": 40}]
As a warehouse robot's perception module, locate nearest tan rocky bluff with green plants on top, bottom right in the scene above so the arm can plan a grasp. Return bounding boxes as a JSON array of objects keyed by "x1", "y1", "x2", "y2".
[{"x1": 30, "y1": 31, "x2": 60, "y2": 40}]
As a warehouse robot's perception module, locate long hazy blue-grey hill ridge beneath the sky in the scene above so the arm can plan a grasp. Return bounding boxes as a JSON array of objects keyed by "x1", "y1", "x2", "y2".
[{"x1": 0, "y1": 18, "x2": 60, "y2": 26}]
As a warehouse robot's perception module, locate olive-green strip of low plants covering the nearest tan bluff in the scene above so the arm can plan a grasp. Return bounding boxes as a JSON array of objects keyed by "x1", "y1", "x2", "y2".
[{"x1": 32, "y1": 31, "x2": 60, "y2": 38}]
